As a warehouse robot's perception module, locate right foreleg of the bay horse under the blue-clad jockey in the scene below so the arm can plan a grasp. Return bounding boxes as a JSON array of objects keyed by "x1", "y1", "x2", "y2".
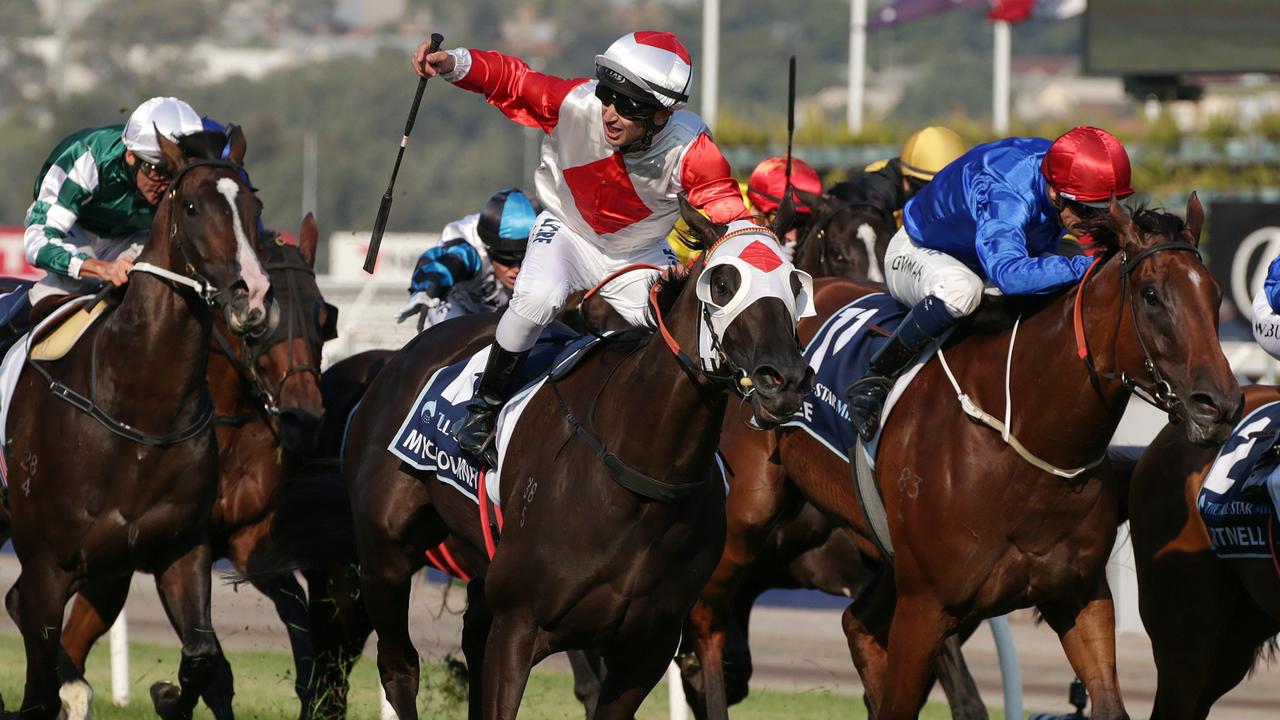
[{"x1": 1039, "y1": 577, "x2": 1129, "y2": 720}]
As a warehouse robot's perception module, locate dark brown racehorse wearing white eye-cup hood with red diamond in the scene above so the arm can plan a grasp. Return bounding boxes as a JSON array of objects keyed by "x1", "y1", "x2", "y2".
[{"x1": 343, "y1": 194, "x2": 813, "y2": 720}]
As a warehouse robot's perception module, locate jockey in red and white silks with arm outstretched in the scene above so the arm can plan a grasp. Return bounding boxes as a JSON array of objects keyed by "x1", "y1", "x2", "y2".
[{"x1": 412, "y1": 32, "x2": 748, "y2": 464}]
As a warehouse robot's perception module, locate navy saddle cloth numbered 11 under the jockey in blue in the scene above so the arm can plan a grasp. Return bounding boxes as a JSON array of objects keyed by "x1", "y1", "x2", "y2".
[{"x1": 785, "y1": 292, "x2": 937, "y2": 468}]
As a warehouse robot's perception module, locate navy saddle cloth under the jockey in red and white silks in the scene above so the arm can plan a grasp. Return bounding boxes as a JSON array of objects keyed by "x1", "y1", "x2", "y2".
[{"x1": 387, "y1": 325, "x2": 599, "y2": 505}]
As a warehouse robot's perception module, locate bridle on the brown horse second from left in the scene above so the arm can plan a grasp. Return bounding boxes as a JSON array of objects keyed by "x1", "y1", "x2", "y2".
[{"x1": 214, "y1": 240, "x2": 334, "y2": 434}]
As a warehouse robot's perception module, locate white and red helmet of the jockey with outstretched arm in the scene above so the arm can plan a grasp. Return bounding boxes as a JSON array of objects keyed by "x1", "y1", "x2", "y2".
[{"x1": 595, "y1": 31, "x2": 694, "y2": 110}]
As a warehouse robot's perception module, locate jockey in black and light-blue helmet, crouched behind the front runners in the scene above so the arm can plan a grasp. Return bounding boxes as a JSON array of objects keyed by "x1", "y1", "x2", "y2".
[{"x1": 399, "y1": 187, "x2": 541, "y2": 325}]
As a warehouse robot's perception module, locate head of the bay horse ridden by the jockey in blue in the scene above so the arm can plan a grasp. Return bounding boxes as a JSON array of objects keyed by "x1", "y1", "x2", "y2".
[{"x1": 1102, "y1": 193, "x2": 1244, "y2": 446}]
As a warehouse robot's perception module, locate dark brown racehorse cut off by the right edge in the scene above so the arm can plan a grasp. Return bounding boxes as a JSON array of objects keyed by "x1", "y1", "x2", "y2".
[{"x1": 1129, "y1": 386, "x2": 1280, "y2": 720}]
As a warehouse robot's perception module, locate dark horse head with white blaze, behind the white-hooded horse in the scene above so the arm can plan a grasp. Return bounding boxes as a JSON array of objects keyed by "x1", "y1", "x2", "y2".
[{"x1": 796, "y1": 183, "x2": 897, "y2": 282}]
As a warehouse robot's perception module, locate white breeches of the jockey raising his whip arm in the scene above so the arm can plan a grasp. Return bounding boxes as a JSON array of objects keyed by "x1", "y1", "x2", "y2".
[{"x1": 495, "y1": 213, "x2": 676, "y2": 352}]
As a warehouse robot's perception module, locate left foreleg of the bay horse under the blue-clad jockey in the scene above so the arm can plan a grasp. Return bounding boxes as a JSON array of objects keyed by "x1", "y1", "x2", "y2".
[{"x1": 873, "y1": 589, "x2": 951, "y2": 720}]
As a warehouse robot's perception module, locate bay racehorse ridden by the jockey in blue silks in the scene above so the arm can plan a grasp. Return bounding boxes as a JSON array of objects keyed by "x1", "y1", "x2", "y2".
[{"x1": 703, "y1": 196, "x2": 1242, "y2": 720}]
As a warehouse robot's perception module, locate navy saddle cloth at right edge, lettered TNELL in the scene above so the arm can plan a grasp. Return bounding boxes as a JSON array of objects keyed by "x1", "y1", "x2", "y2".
[{"x1": 1196, "y1": 402, "x2": 1280, "y2": 557}]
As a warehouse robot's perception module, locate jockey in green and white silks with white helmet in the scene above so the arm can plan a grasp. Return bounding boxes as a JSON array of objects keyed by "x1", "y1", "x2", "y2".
[{"x1": 23, "y1": 97, "x2": 204, "y2": 305}]
